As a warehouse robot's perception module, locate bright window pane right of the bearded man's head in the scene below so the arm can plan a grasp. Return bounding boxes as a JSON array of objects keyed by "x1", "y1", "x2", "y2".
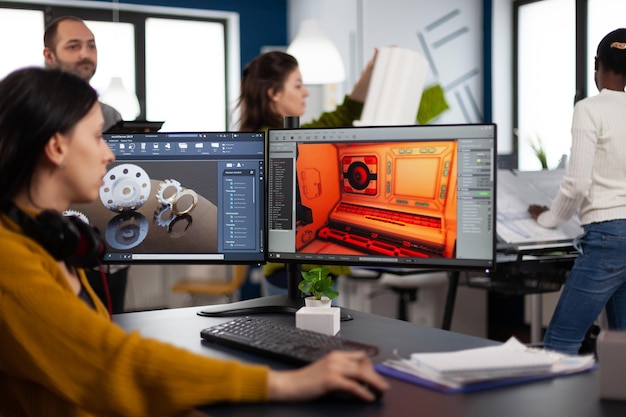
[{"x1": 146, "y1": 18, "x2": 227, "y2": 131}]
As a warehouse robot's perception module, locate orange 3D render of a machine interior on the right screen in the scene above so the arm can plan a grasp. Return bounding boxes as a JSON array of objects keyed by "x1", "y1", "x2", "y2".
[{"x1": 296, "y1": 141, "x2": 457, "y2": 258}]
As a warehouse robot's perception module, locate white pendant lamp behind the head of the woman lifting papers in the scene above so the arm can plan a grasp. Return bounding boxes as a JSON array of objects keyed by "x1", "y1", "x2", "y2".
[{"x1": 287, "y1": 19, "x2": 346, "y2": 84}]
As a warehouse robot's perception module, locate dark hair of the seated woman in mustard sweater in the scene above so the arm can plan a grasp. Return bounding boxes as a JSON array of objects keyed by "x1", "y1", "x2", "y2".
[{"x1": 0, "y1": 68, "x2": 98, "y2": 201}]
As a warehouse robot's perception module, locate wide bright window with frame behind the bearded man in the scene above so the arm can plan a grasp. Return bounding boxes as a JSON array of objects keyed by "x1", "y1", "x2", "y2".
[{"x1": 0, "y1": 0, "x2": 240, "y2": 131}]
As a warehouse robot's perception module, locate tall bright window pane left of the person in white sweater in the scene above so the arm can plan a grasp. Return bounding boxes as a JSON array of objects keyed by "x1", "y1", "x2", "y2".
[{"x1": 516, "y1": 0, "x2": 576, "y2": 171}]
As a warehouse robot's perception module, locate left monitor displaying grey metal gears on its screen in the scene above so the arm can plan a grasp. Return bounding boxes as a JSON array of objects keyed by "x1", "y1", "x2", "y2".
[{"x1": 70, "y1": 132, "x2": 266, "y2": 264}]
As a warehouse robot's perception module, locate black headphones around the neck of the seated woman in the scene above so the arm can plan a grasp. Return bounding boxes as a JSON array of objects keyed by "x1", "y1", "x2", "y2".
[{"x1": 2, "y1": 200, "x2": 106, "y2": 268}]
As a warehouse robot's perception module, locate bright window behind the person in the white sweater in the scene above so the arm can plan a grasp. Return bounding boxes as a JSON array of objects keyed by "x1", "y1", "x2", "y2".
[{"x1": 514, "y1": 0, "x2": 626, "y2": 170}]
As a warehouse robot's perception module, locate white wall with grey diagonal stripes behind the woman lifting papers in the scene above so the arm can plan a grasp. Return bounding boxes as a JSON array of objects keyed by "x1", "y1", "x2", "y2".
[{"x1": 288, "y1": 0, "x2": 513, "y2": 153}]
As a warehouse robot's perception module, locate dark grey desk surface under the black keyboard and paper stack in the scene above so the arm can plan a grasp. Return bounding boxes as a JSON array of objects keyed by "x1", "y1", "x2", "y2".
[{"x1": 114, "y1": 307, "x2": 626, "y2": 417}]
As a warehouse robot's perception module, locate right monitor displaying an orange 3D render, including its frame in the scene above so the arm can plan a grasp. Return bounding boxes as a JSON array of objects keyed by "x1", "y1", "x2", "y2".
[{"x1": 268, "y1": 124, "x2": 497, "y2": 269}]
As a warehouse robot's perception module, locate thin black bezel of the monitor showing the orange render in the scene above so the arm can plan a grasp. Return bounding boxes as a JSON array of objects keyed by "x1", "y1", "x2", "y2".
[{"x1": 267, "y1": 123, "x2": 497, "y2": 271}]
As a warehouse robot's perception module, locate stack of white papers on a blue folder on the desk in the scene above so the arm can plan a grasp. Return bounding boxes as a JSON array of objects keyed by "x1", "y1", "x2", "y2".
[{"x1": 377, "y1": 338, "x2": 595, "y2": 392}]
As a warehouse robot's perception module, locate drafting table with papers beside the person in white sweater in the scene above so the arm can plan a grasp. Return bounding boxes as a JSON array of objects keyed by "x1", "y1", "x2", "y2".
[{"x1": 485, "y1": 169, "x2": 583, "y2": 343}]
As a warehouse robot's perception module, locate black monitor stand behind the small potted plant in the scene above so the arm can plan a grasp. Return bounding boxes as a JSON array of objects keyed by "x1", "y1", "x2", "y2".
[{"x1": 198, "y1": 264, "x2": 353, "y2": 321}]
